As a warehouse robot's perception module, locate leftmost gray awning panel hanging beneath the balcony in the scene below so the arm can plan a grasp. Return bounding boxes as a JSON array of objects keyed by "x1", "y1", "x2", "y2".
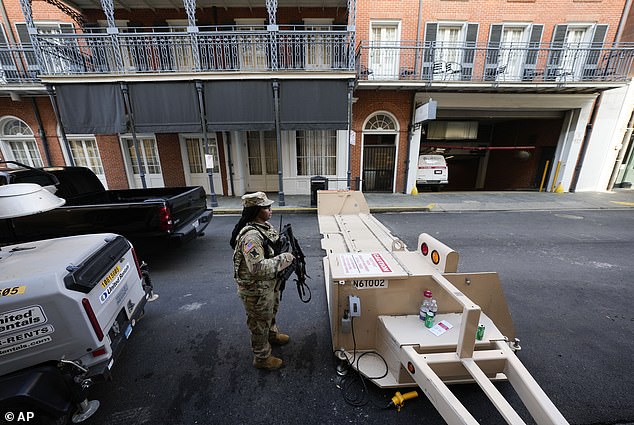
[{"x1": 55, "y1": 84, "x2": 126, "y2": 134}]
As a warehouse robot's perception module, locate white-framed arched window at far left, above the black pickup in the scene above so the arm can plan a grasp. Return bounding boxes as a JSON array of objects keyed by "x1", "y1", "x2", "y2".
[{"x1": 0, "y1": 117, "x2": 44, "y2": 167}]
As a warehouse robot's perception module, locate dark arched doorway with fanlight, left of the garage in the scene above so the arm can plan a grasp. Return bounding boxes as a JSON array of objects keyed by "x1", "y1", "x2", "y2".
[{"x1": 361, "y1": 112, "x2": 398, "y2": 192}]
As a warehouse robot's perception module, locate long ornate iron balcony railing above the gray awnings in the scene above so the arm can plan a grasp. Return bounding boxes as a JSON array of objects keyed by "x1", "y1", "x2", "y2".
[{"x1": 29, "y1": 27, "x2": 354, "y2": 75}]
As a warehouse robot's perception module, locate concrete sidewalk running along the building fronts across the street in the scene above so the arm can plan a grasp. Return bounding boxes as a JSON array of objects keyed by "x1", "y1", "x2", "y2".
[{"x1": 209, "y1": 189, "x2": 634, "y2": 214}]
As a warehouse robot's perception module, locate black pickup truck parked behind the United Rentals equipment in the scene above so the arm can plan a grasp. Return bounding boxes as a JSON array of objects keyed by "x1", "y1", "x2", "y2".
[{"x1": 0, "y1": 163, "x2": 213, "y2": 245}]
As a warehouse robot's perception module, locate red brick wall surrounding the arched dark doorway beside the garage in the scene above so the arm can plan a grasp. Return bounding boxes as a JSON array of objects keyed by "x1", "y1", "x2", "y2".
[{"x1": 350, "y1": 90, "x2": 412, "y2": 192}]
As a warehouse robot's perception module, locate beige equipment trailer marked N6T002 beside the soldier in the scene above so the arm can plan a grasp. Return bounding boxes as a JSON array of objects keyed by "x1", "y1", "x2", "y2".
[{"x1": 317, "y1": 191, "x2": 568, "y2": 424}]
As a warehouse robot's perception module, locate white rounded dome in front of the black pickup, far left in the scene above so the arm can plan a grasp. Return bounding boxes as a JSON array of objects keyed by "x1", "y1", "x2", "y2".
[{"x1": 0, "y1": 183, "x2": 66, "y2": 219}]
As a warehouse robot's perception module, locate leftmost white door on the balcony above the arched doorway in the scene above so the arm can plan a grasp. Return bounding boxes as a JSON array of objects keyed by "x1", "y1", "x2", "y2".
[{"x1": 368, "y1": 23, "x2": 399, "y2": 80}]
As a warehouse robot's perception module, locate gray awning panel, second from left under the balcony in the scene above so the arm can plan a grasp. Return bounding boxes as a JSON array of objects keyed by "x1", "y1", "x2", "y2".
[{"x1": 128, "y1": 82, "x2": 202, "y2": 133}]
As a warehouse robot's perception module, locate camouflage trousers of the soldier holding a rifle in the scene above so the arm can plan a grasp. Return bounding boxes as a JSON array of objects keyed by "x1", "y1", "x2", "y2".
[{"x1": 239, "y1": 282, "x2": 280, "y2": 359}]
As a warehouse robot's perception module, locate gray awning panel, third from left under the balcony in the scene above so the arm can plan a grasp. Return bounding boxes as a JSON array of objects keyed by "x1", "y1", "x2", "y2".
[{"x1": 205, "y1": 80, "x2": 275, "y2": 131}]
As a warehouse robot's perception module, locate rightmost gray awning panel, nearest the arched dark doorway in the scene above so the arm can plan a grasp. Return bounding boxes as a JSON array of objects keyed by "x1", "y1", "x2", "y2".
[{"x1": 280, "y1": 80, "x2": 348, "y2": 130}]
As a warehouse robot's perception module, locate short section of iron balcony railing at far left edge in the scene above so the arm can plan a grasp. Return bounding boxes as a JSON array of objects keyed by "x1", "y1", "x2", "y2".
[{"x1": 0, "y1": 44, "x2": 40, "y2": 87}]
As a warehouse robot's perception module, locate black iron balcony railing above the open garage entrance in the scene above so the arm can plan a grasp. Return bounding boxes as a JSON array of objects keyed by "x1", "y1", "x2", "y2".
[{"x1": 356, "y1": 41, "x2": 634, "y2": 84}]
